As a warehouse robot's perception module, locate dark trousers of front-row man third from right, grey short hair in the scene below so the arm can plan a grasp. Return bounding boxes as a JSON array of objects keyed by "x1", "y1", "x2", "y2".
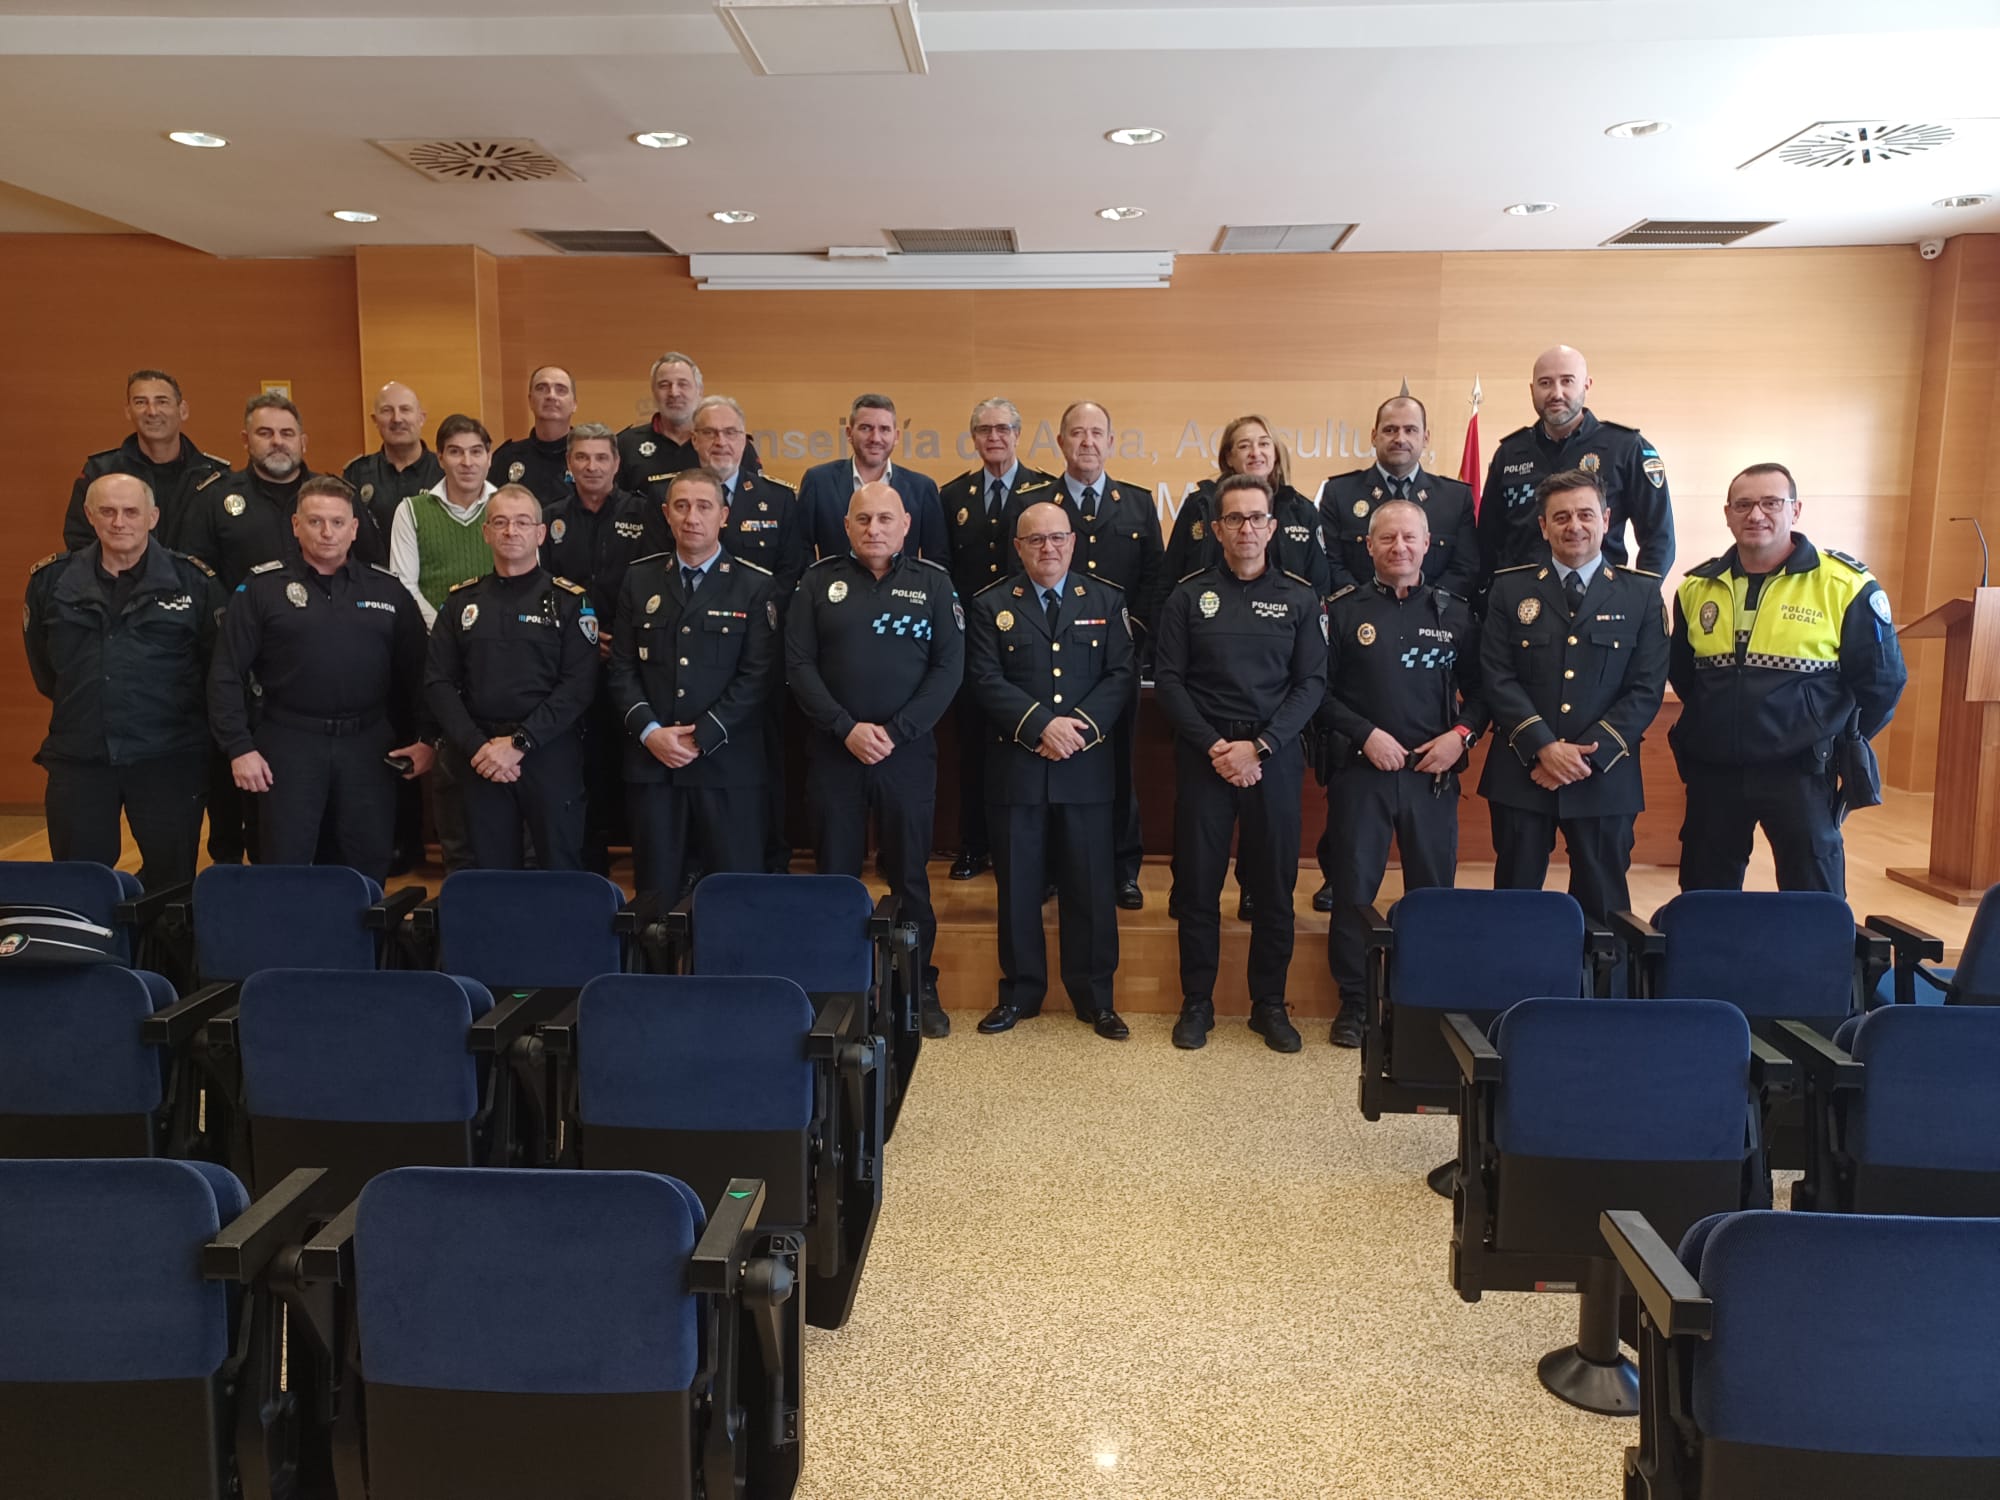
[{"x1": 1326, "y1": 760, "x2": 1458, "y2": 1006}]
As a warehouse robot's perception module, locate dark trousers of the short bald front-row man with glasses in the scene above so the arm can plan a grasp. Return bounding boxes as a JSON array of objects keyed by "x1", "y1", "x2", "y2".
[{"x1": 986, "y1": 802, "x2": 1118, "y2": 1020}]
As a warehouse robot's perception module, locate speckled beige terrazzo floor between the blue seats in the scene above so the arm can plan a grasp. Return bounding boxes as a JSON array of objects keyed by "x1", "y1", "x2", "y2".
[{"x1": 798, "y1": 1010, "x2": 1638, "y2": 1500}]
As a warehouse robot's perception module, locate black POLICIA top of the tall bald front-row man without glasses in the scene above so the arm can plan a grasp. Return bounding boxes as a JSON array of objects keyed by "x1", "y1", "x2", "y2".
[{"x1": 784, "y1": 552, "x2": 966, "y2": 746}]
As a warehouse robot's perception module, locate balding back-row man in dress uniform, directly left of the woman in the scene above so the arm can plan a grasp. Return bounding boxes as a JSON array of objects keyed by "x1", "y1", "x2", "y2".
[{"x1": 1014, "y1": 402, "x2": 1166, "y2": 912}]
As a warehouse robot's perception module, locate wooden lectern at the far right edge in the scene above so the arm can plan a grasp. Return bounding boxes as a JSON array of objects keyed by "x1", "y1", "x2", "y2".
[{"x1": 1888, "y1": 588, "x2": 2000, "y2": 906}]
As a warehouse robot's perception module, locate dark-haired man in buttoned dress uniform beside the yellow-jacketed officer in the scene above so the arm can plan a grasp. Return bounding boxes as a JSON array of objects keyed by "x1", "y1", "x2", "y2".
[{"x1": 1480, "y1": 470, "x2": 1666, "y2": 924}]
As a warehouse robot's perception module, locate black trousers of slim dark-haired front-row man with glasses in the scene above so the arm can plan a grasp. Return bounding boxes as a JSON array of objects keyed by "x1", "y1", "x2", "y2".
[{"x1": 1174, "y1": 734, "x2": 1306, "y2": 1006}]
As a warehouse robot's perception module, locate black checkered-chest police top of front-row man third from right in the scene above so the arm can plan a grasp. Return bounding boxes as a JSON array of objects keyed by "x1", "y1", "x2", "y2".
[{"x1": 1320, "y1": 574, "x2": 1488, "y2": 764}]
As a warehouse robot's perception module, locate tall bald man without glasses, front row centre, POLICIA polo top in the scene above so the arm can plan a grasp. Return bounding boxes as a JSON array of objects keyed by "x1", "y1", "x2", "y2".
[{"x1": 784, "y1": 484, "x2": 966, "y2": 1036}]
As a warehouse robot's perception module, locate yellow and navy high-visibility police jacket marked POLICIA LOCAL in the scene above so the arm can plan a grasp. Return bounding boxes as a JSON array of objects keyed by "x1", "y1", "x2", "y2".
[{"x1": 1668, "y1": 532, "x2": 1908, "y2": 766}]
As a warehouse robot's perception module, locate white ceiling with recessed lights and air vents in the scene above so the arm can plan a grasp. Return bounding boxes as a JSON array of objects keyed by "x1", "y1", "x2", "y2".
[{"x1": 0, "y1": 0, "x2": 2000, "y2": 256}]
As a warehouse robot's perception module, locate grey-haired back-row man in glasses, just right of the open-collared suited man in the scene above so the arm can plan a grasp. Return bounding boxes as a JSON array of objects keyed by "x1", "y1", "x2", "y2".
[{"x1": 938, "y1": 396, "x2": 1076, "y2": 892}]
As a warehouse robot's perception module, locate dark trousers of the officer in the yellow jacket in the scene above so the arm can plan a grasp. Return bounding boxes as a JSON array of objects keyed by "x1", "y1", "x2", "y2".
[{"x1": 1680, "y1": 760, "x2": 1848, "y2": 896}]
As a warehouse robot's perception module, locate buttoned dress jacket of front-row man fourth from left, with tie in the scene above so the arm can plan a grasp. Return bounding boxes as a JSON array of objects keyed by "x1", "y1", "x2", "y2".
[{"x1": 608, "y1": 552, "x2": 778, "y2": 786}]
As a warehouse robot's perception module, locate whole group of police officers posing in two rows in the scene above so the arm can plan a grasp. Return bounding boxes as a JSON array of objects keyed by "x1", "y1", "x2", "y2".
[{"x1": 26, "y1": 348, "x2": 1904, "y2": 1052}]
